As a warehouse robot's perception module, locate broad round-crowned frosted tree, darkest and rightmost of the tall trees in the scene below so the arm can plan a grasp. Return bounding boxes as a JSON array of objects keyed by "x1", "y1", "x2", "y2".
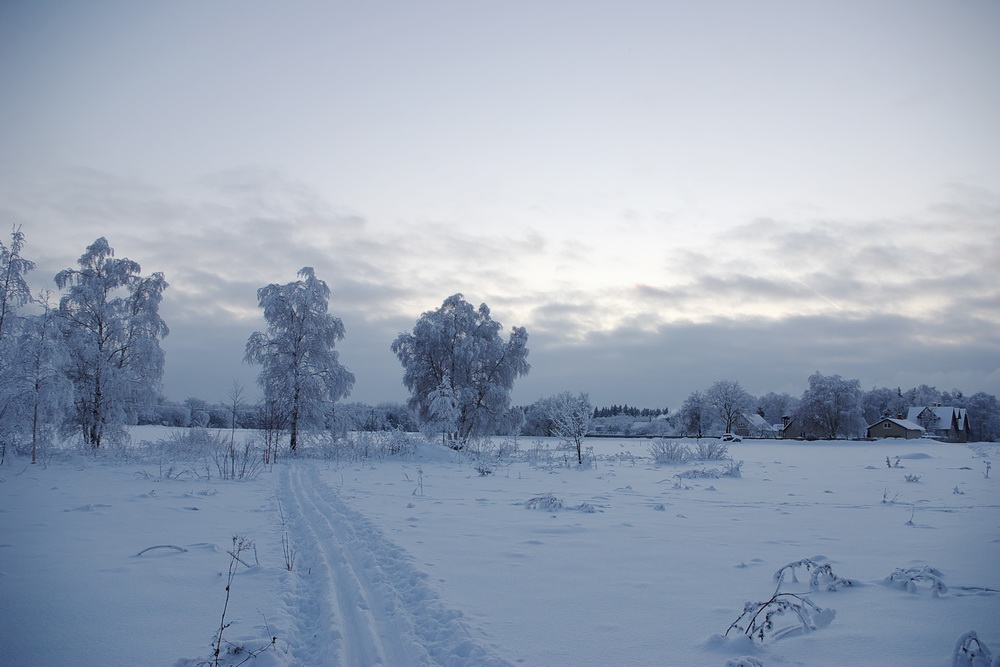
[{"x1": 391, "y1": 294, "x2": 531, "y2": 449}]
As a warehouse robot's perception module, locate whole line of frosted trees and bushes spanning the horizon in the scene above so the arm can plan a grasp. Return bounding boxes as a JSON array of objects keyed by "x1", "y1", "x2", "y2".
[{"x1": 0, "y1": 228, "x2": 1000, "y2": 461}]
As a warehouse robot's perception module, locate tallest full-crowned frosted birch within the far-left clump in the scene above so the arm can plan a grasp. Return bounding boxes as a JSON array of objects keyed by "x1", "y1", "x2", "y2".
[{"x1": 56, "y1": 237, "x2": 169, "y2": 449}]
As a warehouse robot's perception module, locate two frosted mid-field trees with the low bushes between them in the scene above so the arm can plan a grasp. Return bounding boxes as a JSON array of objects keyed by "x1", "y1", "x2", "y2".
[{"x1": 244, "y1": 288, "x2": 532, "y2": 451}]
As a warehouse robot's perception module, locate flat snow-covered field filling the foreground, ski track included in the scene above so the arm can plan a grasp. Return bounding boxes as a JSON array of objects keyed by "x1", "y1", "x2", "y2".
[{"x1": 0, "y1": 429, "x2": 1000, "y2": 667}]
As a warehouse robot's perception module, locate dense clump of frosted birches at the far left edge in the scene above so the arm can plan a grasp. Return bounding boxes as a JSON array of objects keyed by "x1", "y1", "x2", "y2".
[{"x1": 0, "y1": 228, "x2": 168, "y2": 460}]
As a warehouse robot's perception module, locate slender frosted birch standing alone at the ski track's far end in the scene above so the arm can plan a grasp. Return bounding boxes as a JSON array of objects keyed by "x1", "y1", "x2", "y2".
[{"x1": 243, "y1": 266, "x2": 354, "y2": 452}]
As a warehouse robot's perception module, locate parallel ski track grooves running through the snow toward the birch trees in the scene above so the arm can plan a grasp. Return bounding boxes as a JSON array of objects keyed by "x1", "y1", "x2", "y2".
[{"x1": 280, "y1": 463, "x2": 509, "y2": 667}]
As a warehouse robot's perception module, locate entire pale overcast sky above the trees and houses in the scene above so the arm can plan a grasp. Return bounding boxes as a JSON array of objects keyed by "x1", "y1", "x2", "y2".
[{"x1": 0, "y1": 0, "x2": 1000, "y2": 409}]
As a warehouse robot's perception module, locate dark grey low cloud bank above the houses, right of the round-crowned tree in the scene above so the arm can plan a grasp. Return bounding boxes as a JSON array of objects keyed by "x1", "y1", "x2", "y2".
[{"x1": 516, "y1": 315, "x2": 1000, "y2": 409}]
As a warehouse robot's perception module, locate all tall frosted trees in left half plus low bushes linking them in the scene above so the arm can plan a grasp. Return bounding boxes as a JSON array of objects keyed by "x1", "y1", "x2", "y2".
[{"x1": 0, "y1": 228, "x2": 540, "y2": 455}]
